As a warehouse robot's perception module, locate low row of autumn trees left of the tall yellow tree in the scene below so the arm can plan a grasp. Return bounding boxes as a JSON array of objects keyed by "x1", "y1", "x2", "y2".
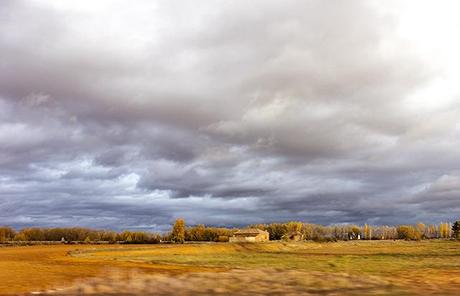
[{"x1": 0, "y1": 227, "x2": 162, "y2": 244}]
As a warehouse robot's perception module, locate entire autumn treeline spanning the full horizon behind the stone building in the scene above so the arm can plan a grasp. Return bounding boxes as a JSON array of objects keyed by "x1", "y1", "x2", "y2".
[{"x1": 0, "y1": 219, "x2": 460, "y2": 244}]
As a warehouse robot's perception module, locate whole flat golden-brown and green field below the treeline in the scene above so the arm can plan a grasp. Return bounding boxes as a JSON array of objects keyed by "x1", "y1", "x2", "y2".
[{"x1": 0, "y1": 241, "x2": 460, "y2": 295}]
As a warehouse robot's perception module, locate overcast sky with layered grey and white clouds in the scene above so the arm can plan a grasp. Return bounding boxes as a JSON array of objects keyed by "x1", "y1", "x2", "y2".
[{"x1": 0, "y1": 0, "x2": 460, "y2": 231}]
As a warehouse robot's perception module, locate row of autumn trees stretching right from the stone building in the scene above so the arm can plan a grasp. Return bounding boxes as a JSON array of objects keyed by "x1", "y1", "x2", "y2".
[{"x1": 250, "y1": 221, "x2": 460, "y2": 241}]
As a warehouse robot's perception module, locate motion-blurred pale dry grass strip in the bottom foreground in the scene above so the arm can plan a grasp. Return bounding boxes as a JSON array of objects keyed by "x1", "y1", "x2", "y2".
[{"x1": 48, "y1": 268, "x2": 398, "y2": 295}]
